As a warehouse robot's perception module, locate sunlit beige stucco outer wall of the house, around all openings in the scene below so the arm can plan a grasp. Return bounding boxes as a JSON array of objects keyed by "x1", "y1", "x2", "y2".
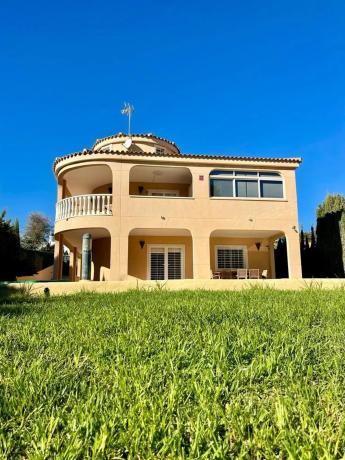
[{"x1": 55, "y1": 140, "x2": 301, "y2": 280}]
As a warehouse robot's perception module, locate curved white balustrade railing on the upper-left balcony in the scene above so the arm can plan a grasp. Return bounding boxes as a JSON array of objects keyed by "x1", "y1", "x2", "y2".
[{"x1": 55, "y1": 193, "x2": 113, "y2": 220}]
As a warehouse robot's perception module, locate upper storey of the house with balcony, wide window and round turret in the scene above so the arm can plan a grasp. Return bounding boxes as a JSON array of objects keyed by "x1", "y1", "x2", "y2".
[{"x1": 54, "y1": 134, "x2": 301, "y2": 226}]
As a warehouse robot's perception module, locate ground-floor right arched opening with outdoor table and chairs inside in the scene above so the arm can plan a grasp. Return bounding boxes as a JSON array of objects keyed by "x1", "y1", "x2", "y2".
[{"x1": 210, "y1": 229, "x2": 282, "y2": 279}]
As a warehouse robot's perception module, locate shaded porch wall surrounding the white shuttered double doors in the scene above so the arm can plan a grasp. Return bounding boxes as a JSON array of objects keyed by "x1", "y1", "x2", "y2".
[{"x1": 128, "y1": 235, "x2": 193, "y2": 280}]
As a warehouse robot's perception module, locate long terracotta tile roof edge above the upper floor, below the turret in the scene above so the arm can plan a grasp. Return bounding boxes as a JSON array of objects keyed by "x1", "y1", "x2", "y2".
[{"x1": 53, "y1": 149, "x2": 302, "y2": 170}]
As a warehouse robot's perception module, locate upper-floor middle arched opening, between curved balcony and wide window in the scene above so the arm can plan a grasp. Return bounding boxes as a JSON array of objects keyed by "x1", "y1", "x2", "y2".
[{"x1": 129, "y1": 166, "x2": 193, "y2": 197}]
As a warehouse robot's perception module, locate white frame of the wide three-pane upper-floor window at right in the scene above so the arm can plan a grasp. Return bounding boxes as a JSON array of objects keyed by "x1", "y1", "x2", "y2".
[{"x1": 209, "y1": 169, "x2": 286, "y2": 201}]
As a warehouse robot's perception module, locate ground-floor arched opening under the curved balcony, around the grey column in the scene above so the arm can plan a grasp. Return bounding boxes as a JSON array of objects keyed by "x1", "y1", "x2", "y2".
[{"x1": 55, "y1": 227, "x2": 111, "y2": 281}]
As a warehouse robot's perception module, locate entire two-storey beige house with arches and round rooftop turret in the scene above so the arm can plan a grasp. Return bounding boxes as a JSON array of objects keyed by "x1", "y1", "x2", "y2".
[{"x1": 54, "y1": 133, "x2": 301, "y2": 281}]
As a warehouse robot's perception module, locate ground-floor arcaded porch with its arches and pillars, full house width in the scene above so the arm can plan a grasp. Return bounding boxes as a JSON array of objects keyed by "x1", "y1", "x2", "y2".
[{"x1": 54, "y1": 228, "x2": 300, "y2": 281}]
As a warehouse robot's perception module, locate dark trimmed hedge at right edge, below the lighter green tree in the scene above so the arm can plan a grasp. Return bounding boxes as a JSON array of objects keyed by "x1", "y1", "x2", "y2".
[{"x1": 316, "y1": 211, "x2": 345, "y2": 278}]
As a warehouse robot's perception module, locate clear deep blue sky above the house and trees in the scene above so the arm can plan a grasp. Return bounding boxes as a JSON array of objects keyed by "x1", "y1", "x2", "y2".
[{"x1": 0, "y1": 0, "x2": 345, "y2": 229}]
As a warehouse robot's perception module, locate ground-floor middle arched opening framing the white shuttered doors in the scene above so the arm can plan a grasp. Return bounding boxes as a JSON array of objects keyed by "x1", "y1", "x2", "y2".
[{"x1": 128, "y1": 228, "x2": 193, "y2": 280}]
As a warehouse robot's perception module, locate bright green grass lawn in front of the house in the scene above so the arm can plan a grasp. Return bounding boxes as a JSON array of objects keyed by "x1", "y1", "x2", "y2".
[{"x1": 0, "y1": 289, "x2": 345, "y2": 459}]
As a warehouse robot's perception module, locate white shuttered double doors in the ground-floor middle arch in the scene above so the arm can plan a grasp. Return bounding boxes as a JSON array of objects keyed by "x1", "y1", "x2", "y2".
[{"x1": 148, "y1": 245, "x2": 184, "y2": 280}]
